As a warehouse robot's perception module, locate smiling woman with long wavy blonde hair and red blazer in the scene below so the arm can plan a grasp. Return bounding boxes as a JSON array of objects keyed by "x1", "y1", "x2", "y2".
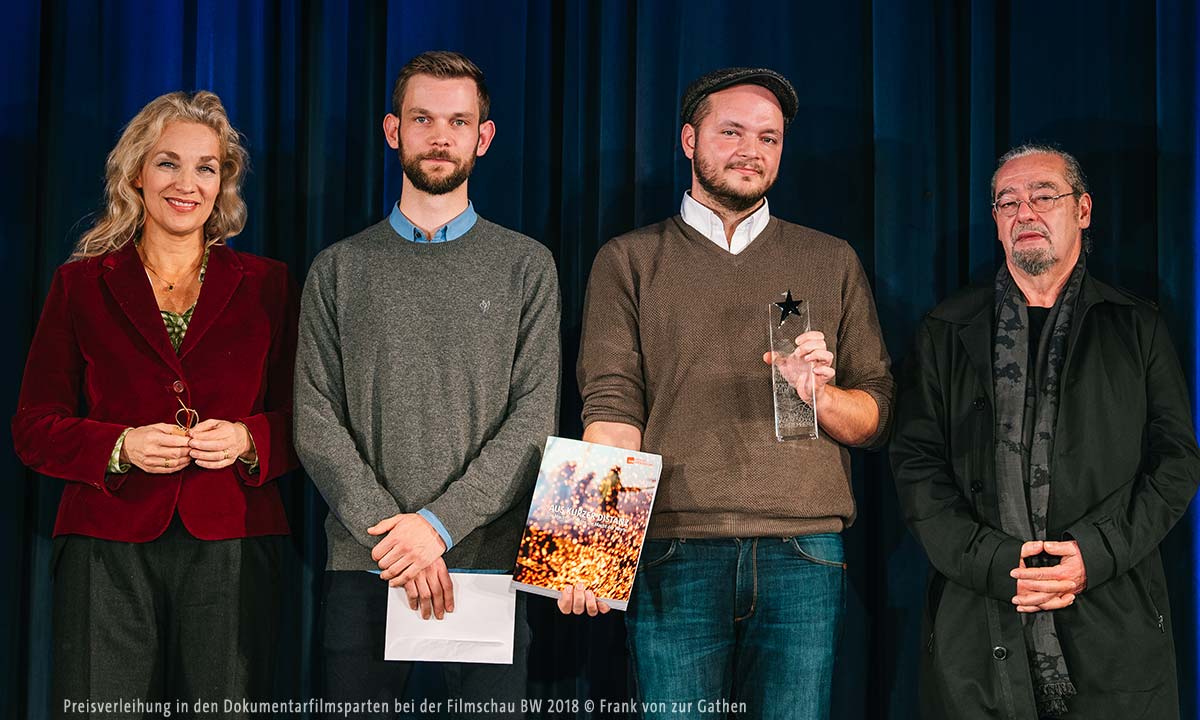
[{"x1": 12, "y1": 91, "x2": 298, "y2": 716}]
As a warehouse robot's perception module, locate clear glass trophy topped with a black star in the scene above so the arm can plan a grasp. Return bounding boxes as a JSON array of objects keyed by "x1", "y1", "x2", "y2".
[{"x1": 767, "y1": 290, "x2": 817, "y2": 442}]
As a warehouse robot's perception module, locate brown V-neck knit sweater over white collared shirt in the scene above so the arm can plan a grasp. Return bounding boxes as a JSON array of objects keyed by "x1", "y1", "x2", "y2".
[{"x1": 578, "y1": 216, "x2": 893, "y2": 539}]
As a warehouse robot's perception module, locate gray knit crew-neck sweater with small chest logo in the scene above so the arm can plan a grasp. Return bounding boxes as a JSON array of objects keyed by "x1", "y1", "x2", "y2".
[{"x1": 295, "y1": 218, "x2": 560, "y2": 570}]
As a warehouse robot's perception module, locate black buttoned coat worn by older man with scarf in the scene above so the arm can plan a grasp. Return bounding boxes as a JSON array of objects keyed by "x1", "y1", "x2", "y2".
[{"x1": 892, "y1": 276, "x2": 1200, "y2": 720}]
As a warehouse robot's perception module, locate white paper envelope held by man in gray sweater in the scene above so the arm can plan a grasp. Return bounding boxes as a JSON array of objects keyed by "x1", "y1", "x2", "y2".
[{"x1": 383, "y1": 572, "x2": 517, "y2": 665}]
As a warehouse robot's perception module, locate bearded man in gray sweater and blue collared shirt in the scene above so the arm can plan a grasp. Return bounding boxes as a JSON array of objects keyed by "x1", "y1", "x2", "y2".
[{"x1": 295, "y1": 52, "x2": 559, "y2": 718}]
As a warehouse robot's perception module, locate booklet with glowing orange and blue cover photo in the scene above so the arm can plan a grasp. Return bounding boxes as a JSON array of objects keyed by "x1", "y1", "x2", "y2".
[{"x1": 512, "y1": 437, "x2": 662, "y2": 610}]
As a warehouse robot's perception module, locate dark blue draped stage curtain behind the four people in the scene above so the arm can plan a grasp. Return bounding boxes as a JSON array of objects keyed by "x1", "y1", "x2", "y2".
[{"x1": 7, "y1": 0, "x2": 1200, "y2": 719}]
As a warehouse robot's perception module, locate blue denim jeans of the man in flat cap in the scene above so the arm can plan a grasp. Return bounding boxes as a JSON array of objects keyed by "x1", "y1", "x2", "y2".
[{"x1": 625, "y1": 534, "x2": 846, "y2": 720}]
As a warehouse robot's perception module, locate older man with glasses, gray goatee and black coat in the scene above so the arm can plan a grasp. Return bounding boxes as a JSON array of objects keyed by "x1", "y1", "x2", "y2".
[{"x1": 892, "y1": 145, "x2": 1200, "y2": 720}]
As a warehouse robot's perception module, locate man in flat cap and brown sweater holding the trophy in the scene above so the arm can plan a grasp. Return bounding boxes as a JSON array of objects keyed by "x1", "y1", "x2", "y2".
[{"x1": 559, "y1": 68, "x2": 893, "y2": 718}]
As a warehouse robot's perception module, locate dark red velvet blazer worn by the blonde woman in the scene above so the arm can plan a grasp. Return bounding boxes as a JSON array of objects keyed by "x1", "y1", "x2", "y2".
[{"x1": 12, "y1": 244, "x2": 299, "y2": 542}]
